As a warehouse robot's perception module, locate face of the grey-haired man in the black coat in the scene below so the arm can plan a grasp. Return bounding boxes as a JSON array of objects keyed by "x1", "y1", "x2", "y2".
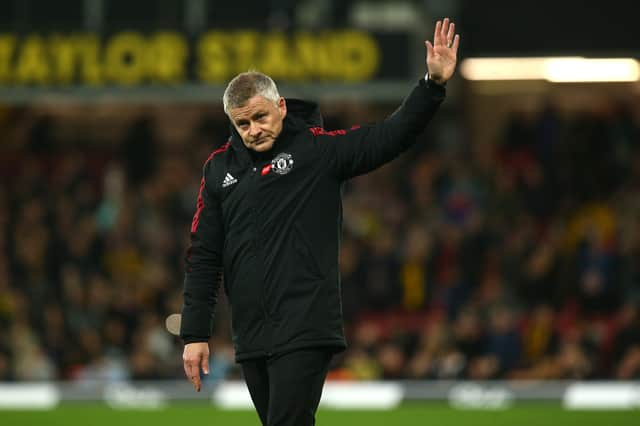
[{"x1": 229, "y1": 95, "x2": 287, "y2": 152}]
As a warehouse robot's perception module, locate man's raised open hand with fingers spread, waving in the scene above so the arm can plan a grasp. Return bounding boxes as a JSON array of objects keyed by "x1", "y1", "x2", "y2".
[{"x1": 424, "y1": 18, "x2": 460, "y2": 84}]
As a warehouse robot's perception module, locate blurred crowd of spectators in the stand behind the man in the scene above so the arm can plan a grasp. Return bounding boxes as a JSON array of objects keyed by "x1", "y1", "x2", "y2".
[{"x1": 0, "y1": 96, "x2": 640, "y2": 381}]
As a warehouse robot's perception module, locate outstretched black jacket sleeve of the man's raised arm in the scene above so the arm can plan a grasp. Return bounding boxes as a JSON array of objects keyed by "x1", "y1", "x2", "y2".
[{"x1": 318, "y1": 79, "x2": 445, "y2": 179}]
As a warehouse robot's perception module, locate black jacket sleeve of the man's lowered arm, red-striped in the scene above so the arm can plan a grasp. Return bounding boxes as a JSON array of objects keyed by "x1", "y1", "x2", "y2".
[{"x1": 180, "y1": 161, "x2": 224, "y2": 344}]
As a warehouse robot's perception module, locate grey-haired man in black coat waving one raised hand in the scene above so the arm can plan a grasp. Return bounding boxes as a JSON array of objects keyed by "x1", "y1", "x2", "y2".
[{"x1": 180, "y1": 19, "x2": 459, "y2": 426}]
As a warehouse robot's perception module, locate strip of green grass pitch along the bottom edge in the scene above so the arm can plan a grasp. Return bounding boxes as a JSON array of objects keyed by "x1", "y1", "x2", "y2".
[{"x1": 0, "y1": 403, "x2": 640, "y2": 426}]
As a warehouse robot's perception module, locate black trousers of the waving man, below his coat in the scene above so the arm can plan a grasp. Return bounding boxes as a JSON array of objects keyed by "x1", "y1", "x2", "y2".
[{"x1": 241, "y1": 348, "x2": 333, "y2": 426}]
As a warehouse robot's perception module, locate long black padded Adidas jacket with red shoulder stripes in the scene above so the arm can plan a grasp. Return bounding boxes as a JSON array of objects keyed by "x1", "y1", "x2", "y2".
[{"x1": 180, "y1": 80, "x2": 445, "y2": 361}]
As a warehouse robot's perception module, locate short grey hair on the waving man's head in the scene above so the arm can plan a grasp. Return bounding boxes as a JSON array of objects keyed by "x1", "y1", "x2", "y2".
[{"x1": 222, "y1": 71, "x2": 280, "y2": 115}]
